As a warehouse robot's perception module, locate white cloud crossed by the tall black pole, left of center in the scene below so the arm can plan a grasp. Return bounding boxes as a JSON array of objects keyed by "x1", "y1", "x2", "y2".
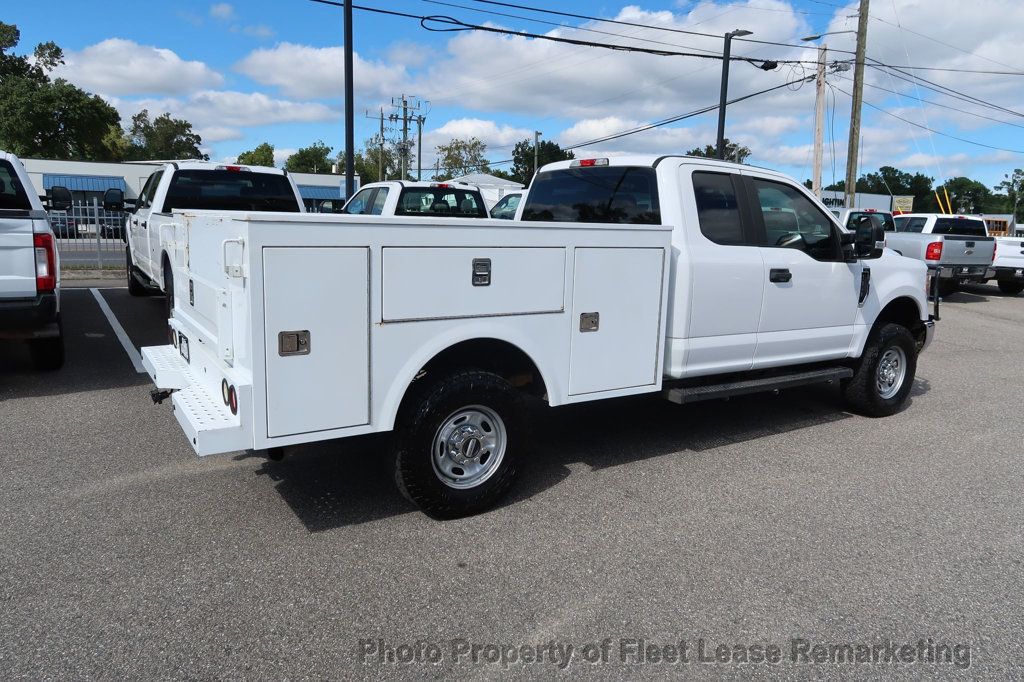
[{"x1": 234, "y1": 42, "x2": 408, "y2": 100}]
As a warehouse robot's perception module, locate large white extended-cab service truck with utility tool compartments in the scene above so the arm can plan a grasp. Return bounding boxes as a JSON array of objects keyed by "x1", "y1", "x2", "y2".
[{"x1": 142, "y1": 156, "x2": 934, "y2": 517}]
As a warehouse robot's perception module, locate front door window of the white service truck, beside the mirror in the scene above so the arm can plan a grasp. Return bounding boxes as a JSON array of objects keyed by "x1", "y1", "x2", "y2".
[{"x1": 751, "y1": 178, "x2": 841, "y2": 260}]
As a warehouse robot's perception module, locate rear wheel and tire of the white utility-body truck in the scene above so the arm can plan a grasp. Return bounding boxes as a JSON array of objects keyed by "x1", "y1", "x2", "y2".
[{"x1": 394, "y1": 370, "x2": 528, "y2": 518}]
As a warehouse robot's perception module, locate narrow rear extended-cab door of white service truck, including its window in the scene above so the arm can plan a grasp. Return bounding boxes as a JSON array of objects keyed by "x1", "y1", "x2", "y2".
[{"x1": 675, "y1": 166, "x2": 765, "y2": 376}]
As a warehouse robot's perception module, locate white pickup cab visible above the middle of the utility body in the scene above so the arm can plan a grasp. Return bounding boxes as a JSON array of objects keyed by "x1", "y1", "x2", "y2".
[{"x1": 342, "y1": 180, "x2": 489, "y2": 218}]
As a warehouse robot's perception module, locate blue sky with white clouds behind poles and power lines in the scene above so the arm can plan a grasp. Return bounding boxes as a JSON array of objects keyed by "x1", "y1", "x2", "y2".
[{"x1": 6, "y1": 0, "x2": 1024, "y2": 186}]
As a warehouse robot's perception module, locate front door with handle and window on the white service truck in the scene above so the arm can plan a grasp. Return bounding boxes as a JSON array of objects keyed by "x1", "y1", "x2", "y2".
[{"x1": 745, "y1": 174, "x2": 863, "y2": 368}]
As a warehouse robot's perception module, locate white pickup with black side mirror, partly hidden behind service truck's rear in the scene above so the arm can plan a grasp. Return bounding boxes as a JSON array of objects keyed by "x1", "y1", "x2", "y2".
[{"x1": 114, "y1": 161, "x2": 305, "y2": 311}]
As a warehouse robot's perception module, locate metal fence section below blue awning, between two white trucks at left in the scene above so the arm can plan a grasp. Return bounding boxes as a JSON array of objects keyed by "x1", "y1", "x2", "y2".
[{"x1": 49, "y1": 199, "x2": 125, "y2": 269}]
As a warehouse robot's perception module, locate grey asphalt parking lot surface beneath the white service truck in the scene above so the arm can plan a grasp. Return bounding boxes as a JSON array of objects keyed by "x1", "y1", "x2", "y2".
[{"x1": 0, "y1": 286, "x2": 1024, "y2": 680}]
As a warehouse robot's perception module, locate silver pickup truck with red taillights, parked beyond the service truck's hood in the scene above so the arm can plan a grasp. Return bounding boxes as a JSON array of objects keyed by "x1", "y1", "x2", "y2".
[{"x1": 886, "y1": 213, "x2": 995, "y2": 296}]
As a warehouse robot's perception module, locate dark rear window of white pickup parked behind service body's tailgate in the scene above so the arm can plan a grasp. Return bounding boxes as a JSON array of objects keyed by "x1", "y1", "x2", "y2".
[{"x1": 164, "y1": 170, "x2": 299, "y2": 213}]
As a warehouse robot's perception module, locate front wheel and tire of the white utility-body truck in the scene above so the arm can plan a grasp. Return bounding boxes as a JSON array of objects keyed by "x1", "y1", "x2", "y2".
[{"x1": 843, "y1": 323, "x2": 918, "y2": 417}]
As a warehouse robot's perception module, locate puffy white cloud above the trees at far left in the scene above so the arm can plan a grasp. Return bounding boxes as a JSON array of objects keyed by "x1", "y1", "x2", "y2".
[{"x1": 54, "y1": 38, "x2": 224, "y2": 95}]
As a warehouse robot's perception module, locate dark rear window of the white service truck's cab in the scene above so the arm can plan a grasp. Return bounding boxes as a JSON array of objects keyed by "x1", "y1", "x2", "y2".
[{"x1": 522, "y1": 166, "x2": 662, "y2": 225}]
